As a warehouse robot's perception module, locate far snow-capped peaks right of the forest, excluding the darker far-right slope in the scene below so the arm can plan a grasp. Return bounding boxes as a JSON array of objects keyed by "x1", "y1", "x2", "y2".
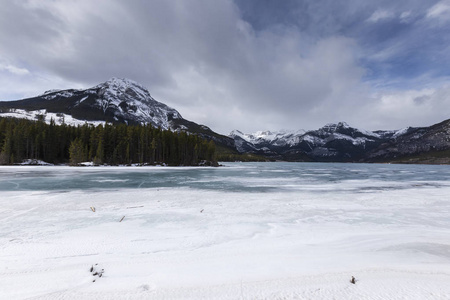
[{"x1": 229, "y1": 122, "x2": 422, "y2": 161}]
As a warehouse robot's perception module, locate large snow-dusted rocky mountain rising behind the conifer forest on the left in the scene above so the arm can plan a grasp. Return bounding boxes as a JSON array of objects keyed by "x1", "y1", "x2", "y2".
[{"x1": 0, "y1": 78, "x2": 234, "y2": 148}]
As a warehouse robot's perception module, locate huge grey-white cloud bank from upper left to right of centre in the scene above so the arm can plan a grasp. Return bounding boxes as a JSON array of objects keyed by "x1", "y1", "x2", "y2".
[{"x1": 1, "y1": 1, "x2": 363, "y2": 129}]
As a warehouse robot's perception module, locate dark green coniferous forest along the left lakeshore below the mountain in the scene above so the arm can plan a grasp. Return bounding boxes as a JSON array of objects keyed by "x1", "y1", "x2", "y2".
[{"x1": 0, "y1": 118, "x2": 217, "y2": 166}]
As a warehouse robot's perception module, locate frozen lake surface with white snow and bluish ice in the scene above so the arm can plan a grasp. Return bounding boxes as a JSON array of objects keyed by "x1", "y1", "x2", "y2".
[{"x1": 0, "y1": 164, "x2": 450, "y2": 299}]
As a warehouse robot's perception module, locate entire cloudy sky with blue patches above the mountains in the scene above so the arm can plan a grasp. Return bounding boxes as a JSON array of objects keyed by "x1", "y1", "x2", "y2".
[{"x1": 0, "y1": 0, "x2": 450, "y2": 134}]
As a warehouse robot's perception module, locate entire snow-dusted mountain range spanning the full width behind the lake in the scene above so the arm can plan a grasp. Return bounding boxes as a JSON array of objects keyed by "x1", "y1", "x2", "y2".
[{"x1": 0, "y1": 78, "x2": 450, "y2": 163}]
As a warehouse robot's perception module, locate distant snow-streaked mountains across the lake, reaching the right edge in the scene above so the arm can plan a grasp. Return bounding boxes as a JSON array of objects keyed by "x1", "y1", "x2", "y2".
[{"x1": 229, "y1": 120, "x2": 450, "y2": 162}]
